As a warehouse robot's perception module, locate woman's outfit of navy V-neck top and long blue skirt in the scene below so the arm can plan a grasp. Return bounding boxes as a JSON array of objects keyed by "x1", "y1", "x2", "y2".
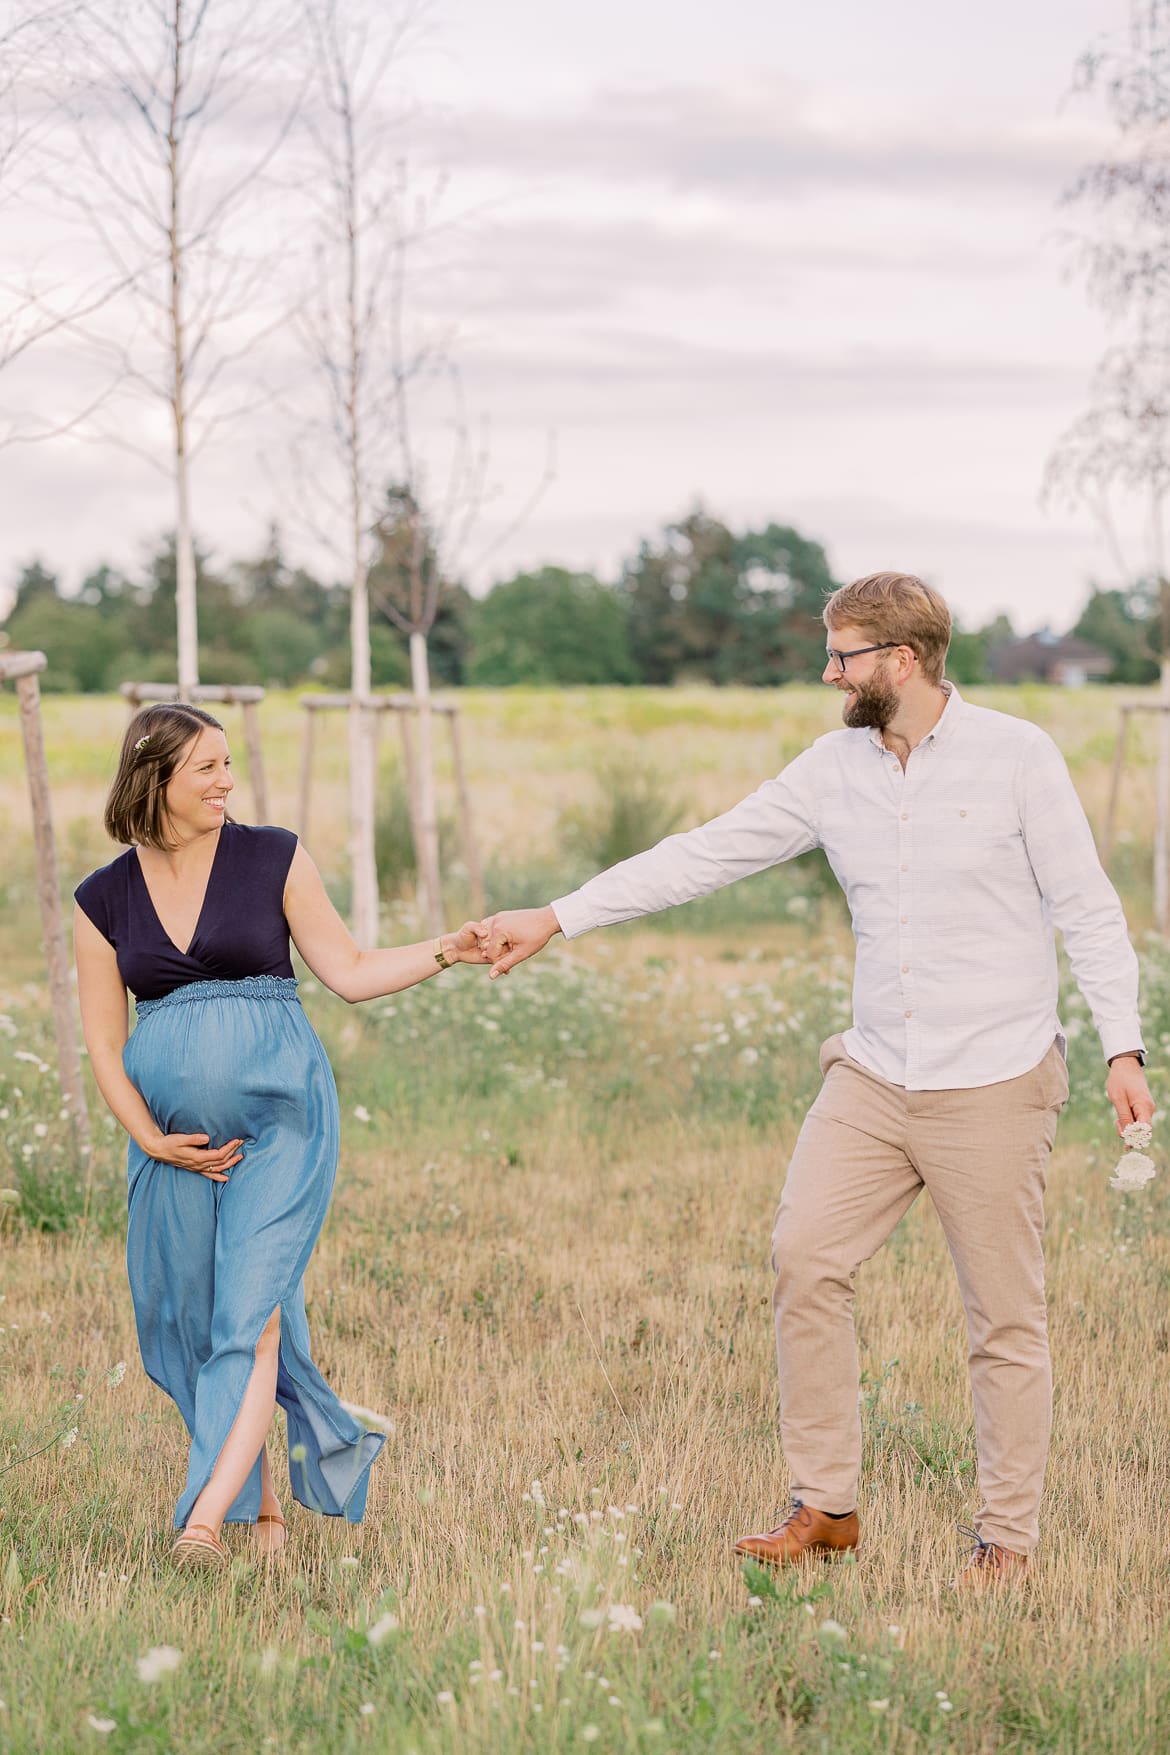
[{"x1": 75, "y1": 823, "x2": 384, "y2": 1529}]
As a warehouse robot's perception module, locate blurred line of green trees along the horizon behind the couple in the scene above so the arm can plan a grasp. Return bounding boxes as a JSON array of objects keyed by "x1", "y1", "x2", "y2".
[{"x1": 0, "y1": 495, "x2": 1158, "y2": 693}]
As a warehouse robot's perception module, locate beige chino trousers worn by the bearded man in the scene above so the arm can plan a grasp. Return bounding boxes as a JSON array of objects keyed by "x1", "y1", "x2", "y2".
[{"x1": 772, "y1": 1035, "x2": 1068, "y2": 1553}]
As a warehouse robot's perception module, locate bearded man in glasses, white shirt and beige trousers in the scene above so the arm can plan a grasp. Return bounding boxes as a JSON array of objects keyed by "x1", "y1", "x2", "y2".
[{"x1": 484, "y1": 572, "x2": 1154, "y2": 1588}]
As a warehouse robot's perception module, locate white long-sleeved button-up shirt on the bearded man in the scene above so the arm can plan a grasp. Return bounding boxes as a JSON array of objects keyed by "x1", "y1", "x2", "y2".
[{"x1": 553, "y1": 683, "x2": 1144, "y2": 1090}]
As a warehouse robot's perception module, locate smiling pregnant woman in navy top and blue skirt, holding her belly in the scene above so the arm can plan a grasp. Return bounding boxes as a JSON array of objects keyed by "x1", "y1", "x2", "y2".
[{"x1": 74, "y1": 704, "x2": 484, "y2": 1565}]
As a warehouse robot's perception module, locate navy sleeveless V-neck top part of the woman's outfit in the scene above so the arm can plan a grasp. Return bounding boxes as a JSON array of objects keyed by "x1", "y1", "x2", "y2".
[{"x1": 74, "y1": 823, "x2": 296, "y2": 999}]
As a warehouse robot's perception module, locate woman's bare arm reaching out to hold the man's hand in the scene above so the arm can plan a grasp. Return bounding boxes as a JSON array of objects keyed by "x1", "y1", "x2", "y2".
[{"x1": 284, "y1": 844, "x2": 491, "y2": 1006}]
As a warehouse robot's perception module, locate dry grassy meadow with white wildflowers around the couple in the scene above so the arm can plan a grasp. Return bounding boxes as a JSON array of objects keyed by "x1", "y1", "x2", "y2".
[{"x1": 0, "y1": 688, "x2": 1170, "y2": 1755}]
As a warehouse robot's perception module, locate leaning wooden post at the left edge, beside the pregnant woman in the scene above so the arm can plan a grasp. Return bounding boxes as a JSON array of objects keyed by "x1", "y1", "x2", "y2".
[{"x1": 0, "y1": 653, "x2": 91, "y2": 1153}]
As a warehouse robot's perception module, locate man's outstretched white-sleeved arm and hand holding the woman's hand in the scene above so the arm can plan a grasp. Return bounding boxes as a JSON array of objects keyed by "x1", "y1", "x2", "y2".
[{"x1": 481, "y1": 749, "x2": 817, "y2": 978}]
